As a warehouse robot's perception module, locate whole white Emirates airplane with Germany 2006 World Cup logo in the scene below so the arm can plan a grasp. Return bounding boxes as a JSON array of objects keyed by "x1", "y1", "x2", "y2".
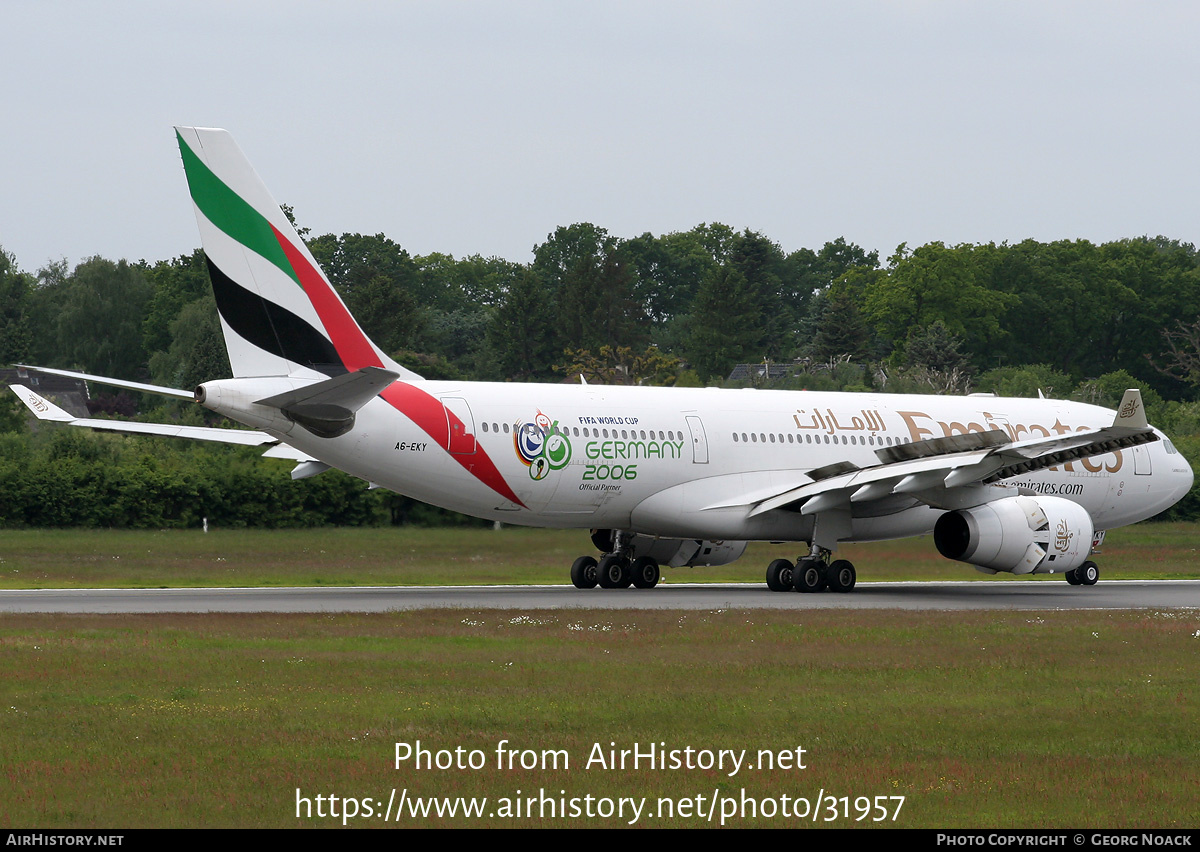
[{"x1": 13, "y1": 127, "x2": 1193, "y2": 593}]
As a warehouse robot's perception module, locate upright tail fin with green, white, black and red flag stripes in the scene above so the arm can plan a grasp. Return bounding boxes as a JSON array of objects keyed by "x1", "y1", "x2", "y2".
[{"x1": 175, "y1": 127, "x2": 420, "y2": 379}]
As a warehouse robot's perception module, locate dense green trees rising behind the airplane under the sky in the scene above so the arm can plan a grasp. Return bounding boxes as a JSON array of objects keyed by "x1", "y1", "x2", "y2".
[{"x1": 0, "y1": 222, "x2": 1200, "y2": 526}]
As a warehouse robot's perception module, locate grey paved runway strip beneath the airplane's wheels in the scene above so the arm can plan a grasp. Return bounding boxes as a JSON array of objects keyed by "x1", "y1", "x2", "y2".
[{"x1": 0, "y1": 580, "x2": 1200, "y2": 613}]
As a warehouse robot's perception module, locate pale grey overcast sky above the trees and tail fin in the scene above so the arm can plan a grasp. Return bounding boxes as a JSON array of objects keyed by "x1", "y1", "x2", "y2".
[{"x1": 0, "y1": 0, "x2": 1200, "y2": 271}]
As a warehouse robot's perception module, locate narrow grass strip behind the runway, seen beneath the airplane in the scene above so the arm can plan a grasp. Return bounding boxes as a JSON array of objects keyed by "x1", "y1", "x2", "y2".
[{"x1": 0, "y1": 523, "x2": 1200, "y2": 589}]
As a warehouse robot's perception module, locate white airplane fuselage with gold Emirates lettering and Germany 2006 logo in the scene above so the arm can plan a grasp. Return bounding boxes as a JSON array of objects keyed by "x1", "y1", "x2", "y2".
[{"x1": 196, "y1": 379, "x2": 1192, "y2": 541}]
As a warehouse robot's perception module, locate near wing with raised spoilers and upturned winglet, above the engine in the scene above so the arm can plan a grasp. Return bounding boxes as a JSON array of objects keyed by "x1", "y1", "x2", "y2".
[{"x1": 749, "y1": 389, "x2": 1158, "y2": 517}]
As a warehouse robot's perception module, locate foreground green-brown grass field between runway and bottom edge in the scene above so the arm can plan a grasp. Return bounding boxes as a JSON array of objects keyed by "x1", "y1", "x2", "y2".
[{"x1": 0, "y1": 611, "x2": 1200, "y2": 828}]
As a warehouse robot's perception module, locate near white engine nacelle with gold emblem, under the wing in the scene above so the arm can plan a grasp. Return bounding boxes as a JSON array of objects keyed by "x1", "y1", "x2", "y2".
[{"x1": 934, "y1": 497, "x2": 1094, "y2": 574}]
